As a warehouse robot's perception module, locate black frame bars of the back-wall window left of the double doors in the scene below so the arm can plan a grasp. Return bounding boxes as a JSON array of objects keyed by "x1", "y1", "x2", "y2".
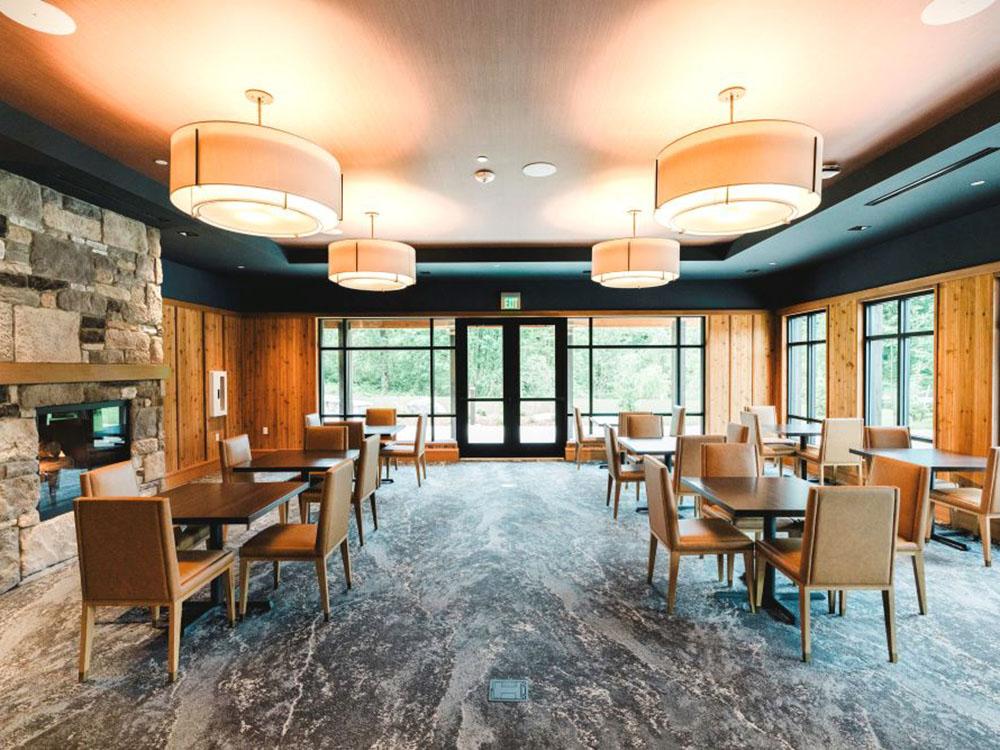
[{"x1": 316, "y1": 316, "x2": 458, "y2": 441}]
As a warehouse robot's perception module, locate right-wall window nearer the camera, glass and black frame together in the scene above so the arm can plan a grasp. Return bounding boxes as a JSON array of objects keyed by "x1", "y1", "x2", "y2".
[{"x1": 865, "y1": 292, "x2": 934, "y2": 441}]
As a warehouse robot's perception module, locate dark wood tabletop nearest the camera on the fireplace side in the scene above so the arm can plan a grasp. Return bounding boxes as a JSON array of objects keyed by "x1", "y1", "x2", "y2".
[{"x1": 159, "y1": 482, "x2": 309, "y2": 525}]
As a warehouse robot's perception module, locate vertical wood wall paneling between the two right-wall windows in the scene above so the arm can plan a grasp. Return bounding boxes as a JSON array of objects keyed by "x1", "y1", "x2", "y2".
[{"x1": 826, "y1": 299, "x2": 863, "y2": 417}]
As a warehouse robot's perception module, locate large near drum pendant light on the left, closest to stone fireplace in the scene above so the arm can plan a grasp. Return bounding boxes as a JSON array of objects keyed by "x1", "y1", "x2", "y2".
[{"x1": 170, "y1": 89, "x2": 342, "y2": 237}]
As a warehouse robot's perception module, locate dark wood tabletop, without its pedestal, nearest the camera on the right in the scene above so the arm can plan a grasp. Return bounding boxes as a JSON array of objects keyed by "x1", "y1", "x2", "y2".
[{"x1": 683, "y1": 477, "x2": 815, "y2": 518}]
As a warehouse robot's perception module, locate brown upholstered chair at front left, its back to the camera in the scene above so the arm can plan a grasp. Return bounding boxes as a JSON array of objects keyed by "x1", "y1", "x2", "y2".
[{"x1": 73, "y1": 497, "x2": 236, "y2": 682}]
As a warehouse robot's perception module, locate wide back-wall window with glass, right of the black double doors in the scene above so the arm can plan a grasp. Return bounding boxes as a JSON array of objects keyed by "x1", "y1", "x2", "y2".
[{"x1": 567, "y1": 317, "x2": 705, "y2": 432}]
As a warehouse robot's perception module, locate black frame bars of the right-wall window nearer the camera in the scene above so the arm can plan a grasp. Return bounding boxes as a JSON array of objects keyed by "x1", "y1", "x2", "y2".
[{"x1": 862, "y1": 289, "x2": 938, "y2": 445}]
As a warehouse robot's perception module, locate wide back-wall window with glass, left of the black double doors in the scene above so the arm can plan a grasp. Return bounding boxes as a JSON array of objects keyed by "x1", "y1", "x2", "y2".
[{"x1": 319, "y1": 318, "x2": 455, "y2": 440}]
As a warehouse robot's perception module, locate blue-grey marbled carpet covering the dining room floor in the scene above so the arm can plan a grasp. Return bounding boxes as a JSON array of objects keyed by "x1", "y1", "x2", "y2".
[{"x1": 0, "y1": 462, "x2": 1000, "y2": 748}]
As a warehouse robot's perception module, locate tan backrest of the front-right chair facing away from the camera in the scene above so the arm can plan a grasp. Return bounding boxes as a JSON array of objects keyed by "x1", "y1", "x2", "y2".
[{"x1": 799, "y1": 487, "x2": 899, "y2": 588}]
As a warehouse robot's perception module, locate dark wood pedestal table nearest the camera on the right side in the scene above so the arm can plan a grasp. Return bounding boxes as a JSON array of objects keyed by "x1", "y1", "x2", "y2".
[{"x1": 682, "y1": 477, "x2": 814, "y2": 625}]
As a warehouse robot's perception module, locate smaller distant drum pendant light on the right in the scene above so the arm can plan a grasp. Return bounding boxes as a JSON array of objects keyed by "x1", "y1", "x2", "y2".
[{"x1": 590, "y1": 209, "x2": 681, "y2": 289}]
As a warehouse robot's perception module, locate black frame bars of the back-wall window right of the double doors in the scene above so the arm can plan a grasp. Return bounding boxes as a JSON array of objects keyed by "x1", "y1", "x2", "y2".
[{"x1": 566, "y1": 315, "x2": 707, "y2": 430}]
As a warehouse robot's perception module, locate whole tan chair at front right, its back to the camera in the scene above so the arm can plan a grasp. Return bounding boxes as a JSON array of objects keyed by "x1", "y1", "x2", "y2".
[{"x1": 756, "y1": 487, "x2": 899, "y2": 662}]
